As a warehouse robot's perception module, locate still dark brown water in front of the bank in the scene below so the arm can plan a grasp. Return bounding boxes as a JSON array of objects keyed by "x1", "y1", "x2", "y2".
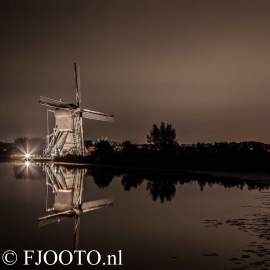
[{"x1": 0, "y1": 163, "x2": 270, "y2": 269}]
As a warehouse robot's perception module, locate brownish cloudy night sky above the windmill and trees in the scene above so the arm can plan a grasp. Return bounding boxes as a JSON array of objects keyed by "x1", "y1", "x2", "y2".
[{"x1": 0, "y1": 0, "x2": 270, "y2": 143}]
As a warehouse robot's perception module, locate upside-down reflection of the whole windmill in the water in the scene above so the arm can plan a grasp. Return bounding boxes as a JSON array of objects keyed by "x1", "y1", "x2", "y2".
[{"x1": 38, "y1": 163, "x2": 113, "y2": 250}]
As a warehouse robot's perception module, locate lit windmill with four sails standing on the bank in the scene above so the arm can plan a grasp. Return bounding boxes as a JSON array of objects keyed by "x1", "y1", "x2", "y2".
[{"x1": 39, "y1": 63, "x2": 114, "y2": 158}]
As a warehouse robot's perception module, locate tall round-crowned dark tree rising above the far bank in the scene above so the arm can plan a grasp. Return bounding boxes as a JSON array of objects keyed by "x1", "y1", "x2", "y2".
[{"x1": 146, "y1": 122, "x2": 178, "y2": 150}]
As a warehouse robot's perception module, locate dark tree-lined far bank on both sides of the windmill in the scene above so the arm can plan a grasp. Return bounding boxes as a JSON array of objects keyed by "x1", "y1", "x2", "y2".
[{"x1": 3, "y1": 122, "x2": 270, "y2": 171}]
